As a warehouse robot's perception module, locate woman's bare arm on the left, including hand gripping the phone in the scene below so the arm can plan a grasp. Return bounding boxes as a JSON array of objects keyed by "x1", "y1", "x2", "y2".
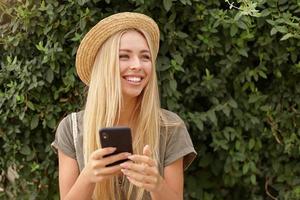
[{"x1": 58, "y1": 147, "x2": 130, "y2": 200}]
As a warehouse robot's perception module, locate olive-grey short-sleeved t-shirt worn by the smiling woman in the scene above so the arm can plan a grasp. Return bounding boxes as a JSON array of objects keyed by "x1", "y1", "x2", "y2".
[{"x1": 52, "y1": 109, "x2": 197, "y2": 198}]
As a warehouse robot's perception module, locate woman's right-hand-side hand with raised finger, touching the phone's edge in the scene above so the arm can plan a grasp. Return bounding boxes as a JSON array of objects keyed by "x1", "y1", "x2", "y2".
[{"x1": 120, "y1": 145, "x2": 163, "y2": 192}]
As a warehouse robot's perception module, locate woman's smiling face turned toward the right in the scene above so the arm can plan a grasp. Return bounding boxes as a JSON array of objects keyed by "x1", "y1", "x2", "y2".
[{"x1": 119, "y1": 30, "x2": 152, "y2": 99}]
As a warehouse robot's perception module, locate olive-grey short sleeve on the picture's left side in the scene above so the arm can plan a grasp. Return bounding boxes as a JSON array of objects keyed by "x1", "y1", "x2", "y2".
[{"x1": 51, "y1": 115, "x2": 76, "y2": 159}]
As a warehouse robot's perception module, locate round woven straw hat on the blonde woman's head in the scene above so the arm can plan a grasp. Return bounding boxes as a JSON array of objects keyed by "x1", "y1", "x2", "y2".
[{"x1": 76, "y1": 12, "x2": 159, "y2": 85}]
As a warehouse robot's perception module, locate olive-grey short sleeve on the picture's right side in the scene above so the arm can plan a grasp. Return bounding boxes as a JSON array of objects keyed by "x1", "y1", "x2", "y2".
[{"x1": 164, "y1": 122, "x2": 197, "y2": 170}]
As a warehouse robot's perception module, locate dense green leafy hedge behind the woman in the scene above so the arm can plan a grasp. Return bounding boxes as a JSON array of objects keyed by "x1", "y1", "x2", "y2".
[{"x1": 0, "y1": 0, "x2": 300, "y2": 200}]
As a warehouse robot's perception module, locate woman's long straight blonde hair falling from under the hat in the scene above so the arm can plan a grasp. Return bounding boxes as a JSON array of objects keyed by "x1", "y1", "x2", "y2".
[{"x1": 83, "y1": 29, "x2": 161, "y2": 200}]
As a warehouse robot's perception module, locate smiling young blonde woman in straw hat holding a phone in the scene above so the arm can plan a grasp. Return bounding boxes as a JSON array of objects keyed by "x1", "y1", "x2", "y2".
[{"x1": 52, "y1": 12, "x2": 196, "y2": 200}]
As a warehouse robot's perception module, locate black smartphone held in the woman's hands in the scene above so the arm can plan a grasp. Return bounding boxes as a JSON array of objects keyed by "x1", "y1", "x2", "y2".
[{"x1": 99, "y1": 127, "x2": 133, "y2": 167}]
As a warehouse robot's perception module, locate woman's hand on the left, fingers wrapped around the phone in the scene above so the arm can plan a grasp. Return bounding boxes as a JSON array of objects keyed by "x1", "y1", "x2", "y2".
[{"x1": 83, "y1": 147, "x2": 131, "y2": 183}]
